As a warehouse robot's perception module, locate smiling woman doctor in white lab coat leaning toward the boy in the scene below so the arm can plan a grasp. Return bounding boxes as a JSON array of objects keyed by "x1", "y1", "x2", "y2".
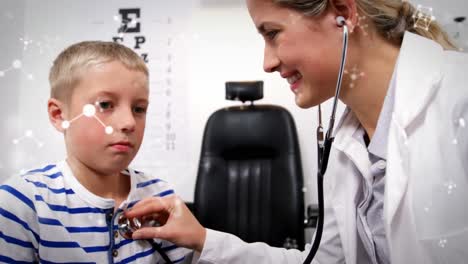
[{"x1": 127, "y1": 0, "x2": 468, "y2": 264}]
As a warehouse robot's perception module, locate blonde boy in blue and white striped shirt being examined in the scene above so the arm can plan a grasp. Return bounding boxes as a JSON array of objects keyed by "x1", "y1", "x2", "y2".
[{"x1": 0, "y1": 41, "x2": 191, "y2": 263}]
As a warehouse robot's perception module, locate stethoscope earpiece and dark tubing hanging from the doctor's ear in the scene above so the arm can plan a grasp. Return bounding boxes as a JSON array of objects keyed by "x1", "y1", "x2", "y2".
[{"x1": 304, "y1": 16, "x2": 348, "y2": 264}]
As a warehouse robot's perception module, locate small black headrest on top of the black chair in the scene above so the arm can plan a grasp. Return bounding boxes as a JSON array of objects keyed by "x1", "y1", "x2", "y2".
[{"x1": 226, "y1": 81, "x2": 263, "y2": 103}]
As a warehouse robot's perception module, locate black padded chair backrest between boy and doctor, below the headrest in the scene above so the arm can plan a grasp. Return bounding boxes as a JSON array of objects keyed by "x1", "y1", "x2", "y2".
[{"x1": 194, "y1": 82, "x2": 304, "y2": 249}]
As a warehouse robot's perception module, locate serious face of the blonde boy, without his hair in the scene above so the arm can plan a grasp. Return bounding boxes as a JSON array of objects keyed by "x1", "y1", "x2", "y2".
[{"x1": 64, "y1": 61, "x2": 148, "y2": 174}]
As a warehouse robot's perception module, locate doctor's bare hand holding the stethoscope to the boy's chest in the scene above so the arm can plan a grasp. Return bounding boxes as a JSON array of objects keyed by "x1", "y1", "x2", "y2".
[{"x1": 125, "y1": 195, "x2": 206, "y2": 252}]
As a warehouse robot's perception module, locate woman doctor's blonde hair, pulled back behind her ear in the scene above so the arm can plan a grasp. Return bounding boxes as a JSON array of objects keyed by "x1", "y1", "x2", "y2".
[{"x1": 273, "y1": 0, "x2": 457, "y2": 50}]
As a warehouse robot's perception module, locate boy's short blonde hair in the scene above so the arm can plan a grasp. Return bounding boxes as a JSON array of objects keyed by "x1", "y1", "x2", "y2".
[{"x1": 49, "y1": 41, "x2": 149, "y2": 101}]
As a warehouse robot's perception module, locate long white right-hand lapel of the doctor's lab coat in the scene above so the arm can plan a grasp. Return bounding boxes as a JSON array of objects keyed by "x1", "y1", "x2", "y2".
[{"x1": 384, "y1": 32, "x2": 443, "y2": 225}]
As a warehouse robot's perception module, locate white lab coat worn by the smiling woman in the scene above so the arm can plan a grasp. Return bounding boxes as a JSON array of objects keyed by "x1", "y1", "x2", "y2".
[{"x1": 198, "y1": 33, "x2": 468, "y2": 264}]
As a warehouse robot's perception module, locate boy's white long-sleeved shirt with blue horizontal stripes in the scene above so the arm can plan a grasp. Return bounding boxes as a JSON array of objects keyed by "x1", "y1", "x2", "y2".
[{"x1": 0, "y1": 161, "x2": 192, "y2": 263}]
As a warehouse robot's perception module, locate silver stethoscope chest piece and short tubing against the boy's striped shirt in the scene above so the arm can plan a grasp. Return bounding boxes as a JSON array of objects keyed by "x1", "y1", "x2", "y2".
[{"x1": 117, "y1": 213, "x2": 173, "y2": 264}]
